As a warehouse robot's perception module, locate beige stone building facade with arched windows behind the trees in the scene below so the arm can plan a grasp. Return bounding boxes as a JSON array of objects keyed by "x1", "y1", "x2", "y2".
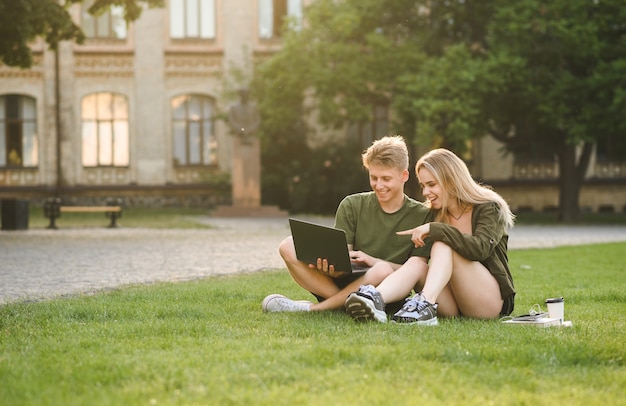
[{"x1": 0, "y1": 0, "x2": 626, "y2": 212}]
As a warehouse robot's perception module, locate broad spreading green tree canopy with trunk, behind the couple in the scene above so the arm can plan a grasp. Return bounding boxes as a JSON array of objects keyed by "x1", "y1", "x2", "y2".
[{"x1": 254, "y1": 0, "x2": 626, "y2": 221}]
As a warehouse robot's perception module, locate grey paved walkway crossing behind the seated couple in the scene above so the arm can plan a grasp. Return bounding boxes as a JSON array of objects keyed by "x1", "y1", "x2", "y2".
[{"x1": 0, "y1": 217, "x2": 626, "y2": 304}]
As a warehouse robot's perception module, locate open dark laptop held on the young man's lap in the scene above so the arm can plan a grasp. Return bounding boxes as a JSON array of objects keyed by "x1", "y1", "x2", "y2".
[{"x1": 289, "y1": 218, "x2": 368, "y2": 273}]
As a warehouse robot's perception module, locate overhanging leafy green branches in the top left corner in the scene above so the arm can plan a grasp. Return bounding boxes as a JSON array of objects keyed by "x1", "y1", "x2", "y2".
[{"x1": 0, "y1": 0, "x2": 163, "y2": 68}]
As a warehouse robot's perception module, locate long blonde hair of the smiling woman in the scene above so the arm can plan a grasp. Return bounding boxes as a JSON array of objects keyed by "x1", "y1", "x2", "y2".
[{"x1": 415, "y1": 148, "x2": 515, "y2": 228}]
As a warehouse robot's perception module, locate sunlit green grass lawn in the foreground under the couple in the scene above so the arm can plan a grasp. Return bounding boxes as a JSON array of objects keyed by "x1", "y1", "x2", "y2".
[{"x1": 0, "y1": 243, "x2": 626, "y2": 406}]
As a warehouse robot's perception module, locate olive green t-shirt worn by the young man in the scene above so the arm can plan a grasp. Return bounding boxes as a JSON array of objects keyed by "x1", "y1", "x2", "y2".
[{"x1": 335, "y1": 192, "x2": 432, "y2": 264}]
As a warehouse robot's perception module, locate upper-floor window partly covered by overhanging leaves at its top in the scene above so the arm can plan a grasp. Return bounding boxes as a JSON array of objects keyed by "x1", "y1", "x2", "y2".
[{"x1": 81, "y1": 0, "x2": 127, "y2": 39}]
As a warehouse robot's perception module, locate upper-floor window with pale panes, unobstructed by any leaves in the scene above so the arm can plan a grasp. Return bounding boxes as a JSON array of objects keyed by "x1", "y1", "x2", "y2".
[{"x1": 170, "y1": 0, "x2": 216, "y2": 39}]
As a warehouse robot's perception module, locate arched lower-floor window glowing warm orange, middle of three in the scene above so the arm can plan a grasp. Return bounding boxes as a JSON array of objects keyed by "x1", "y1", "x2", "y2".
[{"x1": 81, "y1": 93, "x2": 129, "y2": 167}]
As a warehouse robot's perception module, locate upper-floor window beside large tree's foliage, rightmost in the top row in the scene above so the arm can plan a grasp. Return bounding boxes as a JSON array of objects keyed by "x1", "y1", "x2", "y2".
[{"x1": 259, "y1": 0, "x2": 302, "y2": 39}]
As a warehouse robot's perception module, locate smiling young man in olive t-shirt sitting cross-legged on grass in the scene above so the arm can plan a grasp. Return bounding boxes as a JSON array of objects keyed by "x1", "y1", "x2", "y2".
[{"x1": 262, "y1": 136, "x2": 430, "y2": 313}]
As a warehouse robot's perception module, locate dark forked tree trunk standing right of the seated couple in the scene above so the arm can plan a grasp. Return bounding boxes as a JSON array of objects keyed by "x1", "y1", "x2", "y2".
[{"x1": 558, "y1": 142, "x2": 593, "y2": 223}]
